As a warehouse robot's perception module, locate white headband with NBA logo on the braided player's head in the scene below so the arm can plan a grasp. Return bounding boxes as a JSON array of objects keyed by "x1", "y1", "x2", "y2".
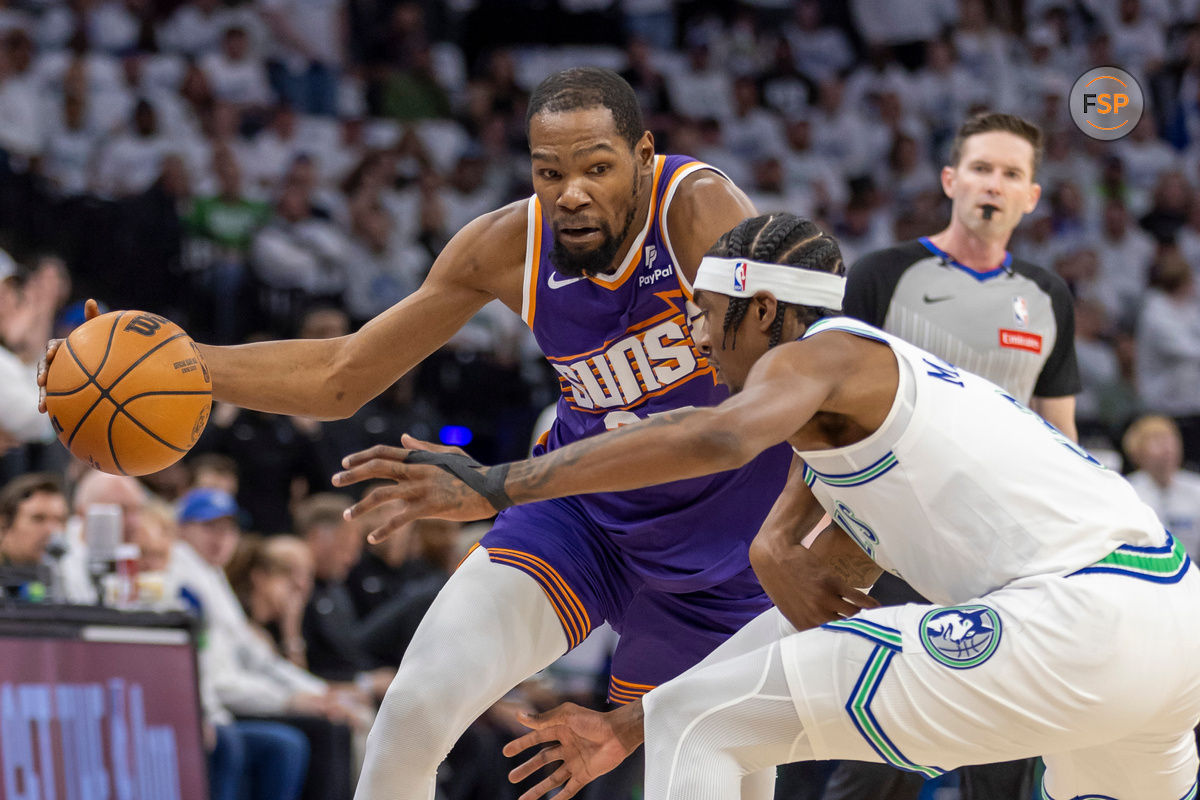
[{"x1": 694, "y1": 255, "x2": 846, "y2": 311}]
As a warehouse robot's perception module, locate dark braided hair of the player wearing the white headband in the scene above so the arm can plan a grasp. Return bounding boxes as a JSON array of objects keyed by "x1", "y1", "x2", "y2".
[{"x1": 708, "y1": 212, "x2": 846, "y2": 349}]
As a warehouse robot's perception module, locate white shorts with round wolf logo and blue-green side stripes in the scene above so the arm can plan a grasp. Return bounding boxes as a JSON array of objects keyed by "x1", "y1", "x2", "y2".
[{"x1": 781, "y1": 566, "x2": 1200, "y2": 800}]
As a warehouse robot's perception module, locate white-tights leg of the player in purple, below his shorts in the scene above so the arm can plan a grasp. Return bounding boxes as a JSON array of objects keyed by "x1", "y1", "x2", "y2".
[{"x1": 354, "y1": 548, "x2": 566, "y2": 800}]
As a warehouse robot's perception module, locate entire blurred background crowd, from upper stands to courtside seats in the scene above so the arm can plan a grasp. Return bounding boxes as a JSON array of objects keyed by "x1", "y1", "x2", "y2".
[{"x1": 9, "y1": 0, "x2": 1200, "y2": 798}]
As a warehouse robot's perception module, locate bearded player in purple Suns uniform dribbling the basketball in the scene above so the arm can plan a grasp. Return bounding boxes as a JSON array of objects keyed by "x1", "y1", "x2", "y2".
[{"x1": 41, "y1": 68, "x2": 791, "y2": 800}]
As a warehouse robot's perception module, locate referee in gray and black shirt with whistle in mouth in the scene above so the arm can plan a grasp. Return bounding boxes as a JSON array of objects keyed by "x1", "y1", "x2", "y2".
[{"x1": 824, "y1": 114, "x2": 1080, "y2": 800}]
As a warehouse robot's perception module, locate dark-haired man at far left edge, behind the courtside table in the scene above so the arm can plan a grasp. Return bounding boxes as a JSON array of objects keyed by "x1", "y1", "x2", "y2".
[{"x1": 0, "y1": 473, "x2": 67, "y2": 601}]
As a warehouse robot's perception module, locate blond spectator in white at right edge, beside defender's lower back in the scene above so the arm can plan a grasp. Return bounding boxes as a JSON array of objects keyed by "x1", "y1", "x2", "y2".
[{"x1": 1121, "y1": 414, "x2": 1200, "y2": 559}]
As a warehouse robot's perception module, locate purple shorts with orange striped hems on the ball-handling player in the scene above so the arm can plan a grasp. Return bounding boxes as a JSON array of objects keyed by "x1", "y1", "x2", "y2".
[{"x1": 480, "y1": 498, "x2": 770, "y2": 703}]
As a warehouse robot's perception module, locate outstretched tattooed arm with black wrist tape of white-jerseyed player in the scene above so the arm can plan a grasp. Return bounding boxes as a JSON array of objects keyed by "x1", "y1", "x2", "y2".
[{"x1": 334, "y1": 342, "x2": 839, "y2": 539}]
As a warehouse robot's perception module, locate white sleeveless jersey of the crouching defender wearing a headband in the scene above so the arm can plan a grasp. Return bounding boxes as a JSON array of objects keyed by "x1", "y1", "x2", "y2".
[{"x1": 798, "y1": 317, "x2": 1168, "y2": 603}]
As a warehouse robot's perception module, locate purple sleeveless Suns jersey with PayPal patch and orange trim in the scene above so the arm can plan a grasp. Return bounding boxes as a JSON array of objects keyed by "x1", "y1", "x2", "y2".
[{"x1": 522, "y1": 156, "x2": 791, "y2": 591}]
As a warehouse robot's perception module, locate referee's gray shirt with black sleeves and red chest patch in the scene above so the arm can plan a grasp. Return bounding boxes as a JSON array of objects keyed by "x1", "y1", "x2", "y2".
[{"x1": 842, "y1": 237, "x2": 1081, "y2": 403}]
